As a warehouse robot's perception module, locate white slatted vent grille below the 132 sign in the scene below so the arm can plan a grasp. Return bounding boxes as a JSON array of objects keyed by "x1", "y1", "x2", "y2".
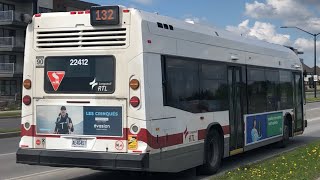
[{"x1": 36, "y1": 28, "x2": 127, "y2": 49}]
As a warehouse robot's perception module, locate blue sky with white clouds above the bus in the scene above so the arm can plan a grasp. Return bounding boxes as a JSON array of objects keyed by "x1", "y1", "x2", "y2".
[{"x1": 86, "y1": 0, "x2": 320, "y2": 67}]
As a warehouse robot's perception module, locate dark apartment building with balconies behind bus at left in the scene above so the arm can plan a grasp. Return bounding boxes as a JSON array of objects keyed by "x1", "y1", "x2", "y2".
[{"x1": 0, "y1": 0, "x2": 97, "y2": 103}]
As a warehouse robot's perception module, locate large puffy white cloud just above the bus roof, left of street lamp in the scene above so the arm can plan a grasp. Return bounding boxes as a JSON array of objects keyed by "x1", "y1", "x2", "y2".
[{"x1": 226, "y1": 20, "x2": 290, "y2": 45}]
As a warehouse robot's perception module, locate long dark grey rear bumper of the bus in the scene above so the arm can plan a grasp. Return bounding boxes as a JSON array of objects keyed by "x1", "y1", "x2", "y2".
[{"x1": 16, "y1": 148, "x2": 149, "y2": 171}]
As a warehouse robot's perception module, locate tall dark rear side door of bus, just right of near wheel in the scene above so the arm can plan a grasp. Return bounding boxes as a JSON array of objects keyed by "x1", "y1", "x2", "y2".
[{"x1": 228, "y1": 66, "x2": 244, "y2": 155}]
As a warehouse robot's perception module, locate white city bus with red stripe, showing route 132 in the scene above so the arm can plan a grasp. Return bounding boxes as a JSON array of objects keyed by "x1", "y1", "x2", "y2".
[{"x1": 16, "y1": 6, "x2": 307, "y2": 174}]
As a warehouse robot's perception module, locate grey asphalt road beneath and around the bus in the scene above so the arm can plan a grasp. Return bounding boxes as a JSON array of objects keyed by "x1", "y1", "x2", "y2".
[{"x1": 0, "y1": 103, "x2": 320, "y2": 180}]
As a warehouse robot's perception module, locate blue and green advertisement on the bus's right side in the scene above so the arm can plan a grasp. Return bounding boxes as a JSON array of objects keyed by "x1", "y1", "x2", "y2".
[{"x1": 244, "y1": 111, "x2": 284, "y2": 146}]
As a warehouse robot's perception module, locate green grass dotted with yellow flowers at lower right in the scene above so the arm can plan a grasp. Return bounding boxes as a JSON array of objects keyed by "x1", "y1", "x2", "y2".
[{"x1": 211, "y1": 141, "x2": 320, "y2": 180}]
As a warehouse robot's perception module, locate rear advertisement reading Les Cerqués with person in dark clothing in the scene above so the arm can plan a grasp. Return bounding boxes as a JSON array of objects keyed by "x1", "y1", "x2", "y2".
[{"x1": 36, "y1": 105, "x2": 123, "y2": 136}]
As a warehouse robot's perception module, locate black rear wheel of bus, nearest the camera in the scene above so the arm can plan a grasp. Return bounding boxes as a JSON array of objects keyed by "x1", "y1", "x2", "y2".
[{"x1": 199, "y1": 130, "x2": 223, "y2": 175}]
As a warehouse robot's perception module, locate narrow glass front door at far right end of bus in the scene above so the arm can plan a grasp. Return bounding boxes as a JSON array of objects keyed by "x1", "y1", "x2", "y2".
[{"x1": 293, "y1": 73, "x2": 304, "y2": 132}]
